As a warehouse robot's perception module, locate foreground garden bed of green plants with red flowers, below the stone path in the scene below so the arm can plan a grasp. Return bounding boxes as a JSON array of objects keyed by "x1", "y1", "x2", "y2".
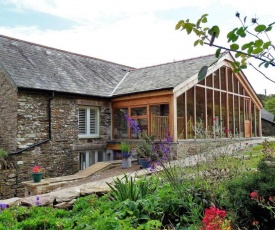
[{"x1": 0, "y1": 139, "x2": 275, "y2": 230}]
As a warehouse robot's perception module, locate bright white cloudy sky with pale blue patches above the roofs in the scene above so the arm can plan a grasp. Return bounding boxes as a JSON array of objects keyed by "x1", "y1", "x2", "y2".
[{"x1": 0, "y1": 0, "x2": 275, "y2": 95}]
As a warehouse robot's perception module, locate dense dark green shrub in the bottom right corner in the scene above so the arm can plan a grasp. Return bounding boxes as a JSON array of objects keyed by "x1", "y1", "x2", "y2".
[{"x1": 225, "y1": 152, "x2": 275, "y2": 229}]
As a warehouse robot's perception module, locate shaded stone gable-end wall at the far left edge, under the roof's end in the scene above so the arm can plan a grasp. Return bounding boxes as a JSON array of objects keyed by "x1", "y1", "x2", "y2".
[{"x1": 0, "y1": 71, "x2": 17, "y2": 152}]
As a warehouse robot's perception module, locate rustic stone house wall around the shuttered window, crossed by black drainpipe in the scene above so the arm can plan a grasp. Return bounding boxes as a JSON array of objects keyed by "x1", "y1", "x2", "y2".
[{"x1": 0, "y1": 91, "x2": 111, "y2": 198}]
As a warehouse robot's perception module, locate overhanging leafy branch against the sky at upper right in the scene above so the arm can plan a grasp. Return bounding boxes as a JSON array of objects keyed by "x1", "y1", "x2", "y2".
[{"x1": 176, "y1": 12, "x2": 275, "y2": 83}]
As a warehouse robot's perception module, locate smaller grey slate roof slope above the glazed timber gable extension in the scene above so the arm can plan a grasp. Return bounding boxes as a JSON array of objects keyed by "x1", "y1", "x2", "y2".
[{"x1": 113, "y1": 55, "x2": 220, "y2": 96}]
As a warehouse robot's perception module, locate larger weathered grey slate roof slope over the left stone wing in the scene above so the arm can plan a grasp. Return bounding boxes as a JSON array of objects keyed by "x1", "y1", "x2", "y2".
[{"x1": 0, "y1": 35, "x2": 132, "y2": 97}]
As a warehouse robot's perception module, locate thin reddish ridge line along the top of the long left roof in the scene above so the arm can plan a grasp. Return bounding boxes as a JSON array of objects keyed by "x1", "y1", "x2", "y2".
[{"x1": 0, "y1": 34, "x2": 136, "y2": 70}]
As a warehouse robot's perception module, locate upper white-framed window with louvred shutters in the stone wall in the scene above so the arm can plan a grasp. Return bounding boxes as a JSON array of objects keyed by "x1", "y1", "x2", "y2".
[{"x1": 78, "y1": 107, "x2": 99, "y2": 138}]
